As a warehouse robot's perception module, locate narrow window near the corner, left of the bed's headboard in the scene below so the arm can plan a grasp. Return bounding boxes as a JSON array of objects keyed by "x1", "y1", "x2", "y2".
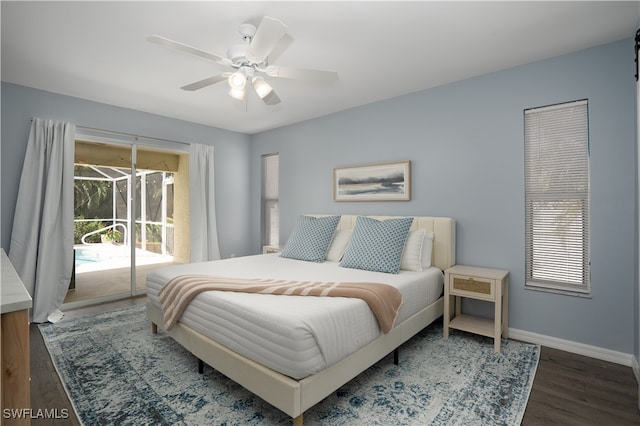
[{"x1": 261, "y1": 154, "x2": 280, "y2": 246}]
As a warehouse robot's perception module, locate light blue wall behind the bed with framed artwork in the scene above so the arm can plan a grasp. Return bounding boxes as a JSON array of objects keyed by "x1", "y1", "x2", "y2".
[{"x1": 251, "y1": 40, "x2": 637, "y2": 354}]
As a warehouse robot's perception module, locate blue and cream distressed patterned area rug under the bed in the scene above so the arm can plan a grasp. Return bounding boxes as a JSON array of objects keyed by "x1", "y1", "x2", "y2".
[{"x1": 40, "y1": 305, "x2": 540, "y2": 426}]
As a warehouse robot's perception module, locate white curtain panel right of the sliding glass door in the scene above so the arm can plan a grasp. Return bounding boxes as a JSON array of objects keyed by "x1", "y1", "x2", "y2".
[{"x1": 189, "y1": 144, "x2": 220, "y2": 262}]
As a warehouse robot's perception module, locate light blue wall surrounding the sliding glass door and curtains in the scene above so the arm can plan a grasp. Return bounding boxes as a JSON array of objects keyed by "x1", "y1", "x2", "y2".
[{"x1": 0, "y1": 83, "x2": 251, "y2": 257}]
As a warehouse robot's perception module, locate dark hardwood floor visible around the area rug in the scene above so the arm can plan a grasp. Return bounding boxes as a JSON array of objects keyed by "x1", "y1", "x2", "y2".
[{"x1": 31, "y1": 297, "x2": 640, "y2": 426}]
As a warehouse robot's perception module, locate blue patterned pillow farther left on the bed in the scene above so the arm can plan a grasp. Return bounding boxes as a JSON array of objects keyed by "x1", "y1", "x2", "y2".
[{"x1": 280, "y1": 216, "x2": 340, "y2": 262}]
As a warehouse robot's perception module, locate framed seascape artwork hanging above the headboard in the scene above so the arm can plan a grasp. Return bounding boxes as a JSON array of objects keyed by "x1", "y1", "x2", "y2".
[{"x1": 333, "y1": 161, "x2": 411, "y2": 201}]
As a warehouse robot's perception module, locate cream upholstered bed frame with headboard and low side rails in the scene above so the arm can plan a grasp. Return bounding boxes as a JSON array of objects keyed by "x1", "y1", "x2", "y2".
[{"x1": 147, "y1": 215, "x2": 456, "y2": 426}]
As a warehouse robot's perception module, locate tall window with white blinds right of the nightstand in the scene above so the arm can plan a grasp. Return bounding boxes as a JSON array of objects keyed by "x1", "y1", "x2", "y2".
[{"x1": 524, "y1": 100, "x2": 590, "y2": 295}]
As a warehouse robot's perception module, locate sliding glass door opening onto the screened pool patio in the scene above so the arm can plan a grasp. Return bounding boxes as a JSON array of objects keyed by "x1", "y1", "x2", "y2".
[{"x1": 64, "y1": 140, "x2": 188, "y2": 307}]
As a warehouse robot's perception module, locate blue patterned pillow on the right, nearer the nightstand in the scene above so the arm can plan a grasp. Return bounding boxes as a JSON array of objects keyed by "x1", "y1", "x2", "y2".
[{"x1": 340, "y1": 216, "x2": 413, "y2": 274}]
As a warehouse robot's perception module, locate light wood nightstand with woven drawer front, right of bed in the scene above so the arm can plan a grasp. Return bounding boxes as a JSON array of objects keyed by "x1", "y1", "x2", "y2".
[{"x1": 443, "y1": 265, "x2": 509, "y2": 352}]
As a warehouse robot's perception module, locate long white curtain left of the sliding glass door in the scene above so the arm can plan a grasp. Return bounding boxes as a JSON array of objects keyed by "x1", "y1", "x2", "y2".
[{"x1": 9, "y1": 118, "x2": 76, "y2": 322}]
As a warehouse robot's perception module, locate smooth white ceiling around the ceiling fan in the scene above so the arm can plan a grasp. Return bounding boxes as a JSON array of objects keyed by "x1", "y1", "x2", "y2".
[{"x1": 1, "y1": 1, "x2": 640, "y2": 134}]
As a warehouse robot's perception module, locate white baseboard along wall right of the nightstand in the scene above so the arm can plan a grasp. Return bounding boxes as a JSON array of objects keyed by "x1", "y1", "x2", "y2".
[{"x1": 509, "y1": 328, "x2": 640, "y2": 368}]
